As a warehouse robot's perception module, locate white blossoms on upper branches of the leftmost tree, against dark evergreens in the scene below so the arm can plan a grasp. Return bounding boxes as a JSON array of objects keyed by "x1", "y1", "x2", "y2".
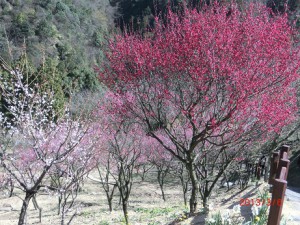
[{"x1": 0, "y1": 70, "x2": 54, "y2": 133}]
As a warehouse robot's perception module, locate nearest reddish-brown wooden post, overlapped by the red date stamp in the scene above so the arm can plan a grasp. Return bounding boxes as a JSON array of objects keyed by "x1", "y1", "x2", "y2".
[{"x1": 268, "y1": 167, "x2": 287, "y2": 225}]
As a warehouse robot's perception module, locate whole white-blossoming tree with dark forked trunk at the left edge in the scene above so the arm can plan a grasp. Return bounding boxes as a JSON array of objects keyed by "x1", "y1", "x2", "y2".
[{"x1": 0, "y1": 62, "x2": 94, "y2": 225}]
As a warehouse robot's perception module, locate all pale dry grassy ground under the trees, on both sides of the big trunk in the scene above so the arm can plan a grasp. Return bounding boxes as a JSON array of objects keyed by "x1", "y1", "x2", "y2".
[{"x1": 0, "y1": 167, "x2": 299, "y2": 225}]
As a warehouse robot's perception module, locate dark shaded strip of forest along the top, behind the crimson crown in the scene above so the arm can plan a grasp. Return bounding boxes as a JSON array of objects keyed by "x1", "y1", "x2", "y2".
[{"x1": 111, "y1": 0, "x2": 300, "y2": 30}]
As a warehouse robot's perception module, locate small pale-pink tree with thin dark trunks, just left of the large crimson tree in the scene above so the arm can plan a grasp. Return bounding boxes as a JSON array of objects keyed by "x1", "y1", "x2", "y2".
[{"x1": 98, "y1": 103, "x2": 144, "y2": 224}]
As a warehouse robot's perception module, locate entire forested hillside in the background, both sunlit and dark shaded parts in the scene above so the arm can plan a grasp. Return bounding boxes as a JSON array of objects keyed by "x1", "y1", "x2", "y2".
[{"x1": 0, "y1": 0, "x2": 299, "y2": 111}]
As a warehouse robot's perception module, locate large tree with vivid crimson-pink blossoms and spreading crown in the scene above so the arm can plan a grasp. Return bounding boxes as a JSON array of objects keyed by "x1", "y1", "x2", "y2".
[{"x1": 99, "y1": 5, "x2": 300, "y2": 213}]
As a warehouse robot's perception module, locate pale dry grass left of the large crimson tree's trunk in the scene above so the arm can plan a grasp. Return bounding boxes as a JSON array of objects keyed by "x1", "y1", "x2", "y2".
[{"x1": 0, "y1": 170, "x2": 187, "y2": 225}]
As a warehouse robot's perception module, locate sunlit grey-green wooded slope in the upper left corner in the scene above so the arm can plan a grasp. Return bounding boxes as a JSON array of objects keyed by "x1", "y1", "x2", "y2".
[{"x1": 0, "y1": 0, "x2": 116, "y2": 93}]
